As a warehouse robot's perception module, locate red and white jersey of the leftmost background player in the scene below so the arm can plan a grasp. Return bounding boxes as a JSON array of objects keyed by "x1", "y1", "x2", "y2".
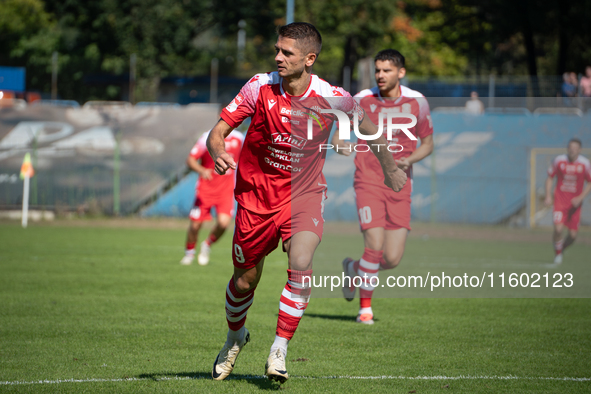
[{"x1": 189, "y1": 130, "x2": 244, "y2": 198}]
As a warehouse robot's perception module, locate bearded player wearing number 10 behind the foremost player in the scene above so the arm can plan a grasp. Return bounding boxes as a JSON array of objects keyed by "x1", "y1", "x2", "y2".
[{"x1": 333, "y1": 49, "x2": 433, "y2": 324}]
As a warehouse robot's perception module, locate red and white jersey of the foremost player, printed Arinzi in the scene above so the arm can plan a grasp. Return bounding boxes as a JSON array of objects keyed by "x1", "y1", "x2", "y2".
[{"x1": 221, "y1": 72, "x2": 362, "y2": 213}]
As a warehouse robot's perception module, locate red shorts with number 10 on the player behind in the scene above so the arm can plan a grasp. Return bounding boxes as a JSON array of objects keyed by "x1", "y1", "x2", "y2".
[{"x1": 355, "y1": 183, "x2": 410, "y2": 231}]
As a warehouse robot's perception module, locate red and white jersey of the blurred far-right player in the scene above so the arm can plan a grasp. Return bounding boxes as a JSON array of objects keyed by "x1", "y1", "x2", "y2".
[{"x1": 548, "y1": 155, "x2": 591, "y2": 209}]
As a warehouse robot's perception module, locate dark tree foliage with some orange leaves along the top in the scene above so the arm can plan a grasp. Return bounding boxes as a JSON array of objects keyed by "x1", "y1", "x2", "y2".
[{"x1": 0, "y1": 0, "x2": 591, "y2": 101}]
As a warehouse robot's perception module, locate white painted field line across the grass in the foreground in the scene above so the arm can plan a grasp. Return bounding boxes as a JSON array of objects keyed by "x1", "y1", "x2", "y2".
[{"x1": 0, "y1": 375, "x2": 591, "y2": 386}]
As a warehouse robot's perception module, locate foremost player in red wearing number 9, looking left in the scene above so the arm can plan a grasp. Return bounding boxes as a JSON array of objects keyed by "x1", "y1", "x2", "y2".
[{"x1": 207, "y1": 22, "x2": 406, "y2": 382}]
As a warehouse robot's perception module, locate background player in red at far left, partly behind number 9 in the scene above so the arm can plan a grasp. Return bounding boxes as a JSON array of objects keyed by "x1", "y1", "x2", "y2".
[{"x1": 181, "y1": 131, "x2": 244, "y2": 265}]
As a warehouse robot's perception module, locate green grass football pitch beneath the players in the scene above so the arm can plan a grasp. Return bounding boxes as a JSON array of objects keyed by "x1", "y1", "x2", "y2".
[{"x1": 0, "y1": 222, "x2": 591, "y2": 393}]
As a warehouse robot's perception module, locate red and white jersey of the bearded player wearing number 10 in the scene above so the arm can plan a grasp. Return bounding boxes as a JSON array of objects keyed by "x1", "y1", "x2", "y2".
[{"x1": 355, "y1": 85, "x2": 433, "y2": 195}]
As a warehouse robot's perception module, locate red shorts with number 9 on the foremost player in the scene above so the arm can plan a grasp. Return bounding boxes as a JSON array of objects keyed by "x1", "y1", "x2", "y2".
[{"x1": 232, "y1": 189, "x2": 326, "y2": 269}]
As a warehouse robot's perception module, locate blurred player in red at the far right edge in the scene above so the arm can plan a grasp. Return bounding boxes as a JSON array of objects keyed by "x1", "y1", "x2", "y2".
[{"x1": 545, "y1": 138, "x2": 591, "y2": 264}]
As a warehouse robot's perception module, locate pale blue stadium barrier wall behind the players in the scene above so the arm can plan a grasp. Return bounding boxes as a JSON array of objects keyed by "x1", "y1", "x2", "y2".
[{"x1": 143, "y1": 113, "x2": 591, "y2": 224}]
